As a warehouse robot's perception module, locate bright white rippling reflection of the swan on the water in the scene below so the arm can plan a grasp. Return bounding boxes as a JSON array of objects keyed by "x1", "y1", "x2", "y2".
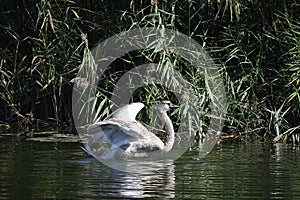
[{"x1": 85, "y1": 160, "x2": 175, "y2": 198}]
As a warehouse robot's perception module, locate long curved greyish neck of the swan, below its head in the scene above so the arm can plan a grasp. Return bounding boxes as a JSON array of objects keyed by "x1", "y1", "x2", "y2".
[{"x1": 158, "y1": 111, "x2": 175, "y2": 152}]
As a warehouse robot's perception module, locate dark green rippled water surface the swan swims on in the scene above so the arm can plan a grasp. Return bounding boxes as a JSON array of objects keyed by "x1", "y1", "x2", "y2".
[{"x1": 0, "y1": 136, "x2": 300, "y2": 200}]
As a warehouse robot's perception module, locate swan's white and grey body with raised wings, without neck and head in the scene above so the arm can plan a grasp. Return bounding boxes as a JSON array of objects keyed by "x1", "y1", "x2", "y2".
[{"x1": 87, "y1": 103, "x2": 164, "y2": 159}]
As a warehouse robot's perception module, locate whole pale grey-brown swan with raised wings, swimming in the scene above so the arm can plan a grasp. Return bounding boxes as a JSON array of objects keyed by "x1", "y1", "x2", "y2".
[{"x1": 85, "y1": 101, "x2": 179, "y2": 159}]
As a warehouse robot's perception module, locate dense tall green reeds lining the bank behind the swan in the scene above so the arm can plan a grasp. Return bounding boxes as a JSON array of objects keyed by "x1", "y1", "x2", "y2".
[{"x1": 0, "y1": 0, "x2": 300, "y2": 143}]
